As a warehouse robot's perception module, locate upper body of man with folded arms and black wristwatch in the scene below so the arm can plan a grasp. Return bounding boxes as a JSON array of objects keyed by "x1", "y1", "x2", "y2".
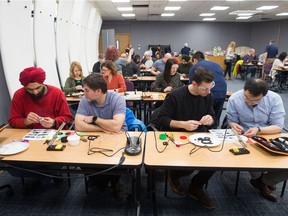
[{"x1": 75, "y1": 74, "x2": 127, "y2": 133}]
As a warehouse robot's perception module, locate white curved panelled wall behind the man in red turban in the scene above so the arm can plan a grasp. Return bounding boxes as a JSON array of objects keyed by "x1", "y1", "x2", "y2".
[{"x1": 0, "y1": 0, "x2": 102, "y2": 122}]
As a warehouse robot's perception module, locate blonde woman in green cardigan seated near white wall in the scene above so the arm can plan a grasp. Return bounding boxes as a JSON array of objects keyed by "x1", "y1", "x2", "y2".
[{"x1": 63, "y1": 61, "x2": 85, "y2": 95}]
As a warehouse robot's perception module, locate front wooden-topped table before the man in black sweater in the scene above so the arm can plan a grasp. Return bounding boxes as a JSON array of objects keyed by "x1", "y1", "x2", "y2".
[{"x1": 144, "y1": 131, "x2": 288, "y2": 215}]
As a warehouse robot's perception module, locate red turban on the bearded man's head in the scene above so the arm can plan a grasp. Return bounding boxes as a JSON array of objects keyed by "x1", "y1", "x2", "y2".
[{"x1": 19, "y1": 67, "x2": 46, "y2": 86}]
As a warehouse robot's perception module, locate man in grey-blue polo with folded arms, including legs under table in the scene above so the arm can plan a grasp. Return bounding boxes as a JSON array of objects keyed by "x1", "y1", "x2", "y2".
[{"x1": 75, "y1": 73, "x2": 127, "y2": 201}]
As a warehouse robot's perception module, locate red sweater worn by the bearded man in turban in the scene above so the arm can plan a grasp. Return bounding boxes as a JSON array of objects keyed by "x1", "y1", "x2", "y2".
[{"x1": 9, "y1": 85, "x2": 73, "y2": 129}]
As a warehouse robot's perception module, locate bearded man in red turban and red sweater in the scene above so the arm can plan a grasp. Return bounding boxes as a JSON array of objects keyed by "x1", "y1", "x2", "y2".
[{"x1": 9, "y1": 67, "x2": 73, "y2": 129}]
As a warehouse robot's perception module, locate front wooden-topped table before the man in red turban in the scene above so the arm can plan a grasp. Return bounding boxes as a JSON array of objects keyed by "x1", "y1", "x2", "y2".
[{"x1": 0, "y1": 128, "x2": 145, "y2": 215}]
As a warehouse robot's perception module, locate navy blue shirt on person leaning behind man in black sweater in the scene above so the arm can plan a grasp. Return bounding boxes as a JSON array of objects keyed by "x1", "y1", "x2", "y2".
[{"x1": 189, "y1": 60, "x2": 227, "y2": 99}]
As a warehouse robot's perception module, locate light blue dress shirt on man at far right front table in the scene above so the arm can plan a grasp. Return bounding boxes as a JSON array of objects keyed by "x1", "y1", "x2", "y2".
[{"x1": 227, "y1": 90, "x2": 285, "y2": 132}]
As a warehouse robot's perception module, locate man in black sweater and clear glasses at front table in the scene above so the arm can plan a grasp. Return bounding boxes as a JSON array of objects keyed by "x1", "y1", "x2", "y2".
[{"x1": 158, "y1": 67, "x2": 215, "y2": 209}]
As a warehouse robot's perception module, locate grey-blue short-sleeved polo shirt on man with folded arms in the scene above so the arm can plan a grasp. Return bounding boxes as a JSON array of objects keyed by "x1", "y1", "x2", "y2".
[{"x1": 77, "y1": 91, "x2": 128, "y2": 131}]
